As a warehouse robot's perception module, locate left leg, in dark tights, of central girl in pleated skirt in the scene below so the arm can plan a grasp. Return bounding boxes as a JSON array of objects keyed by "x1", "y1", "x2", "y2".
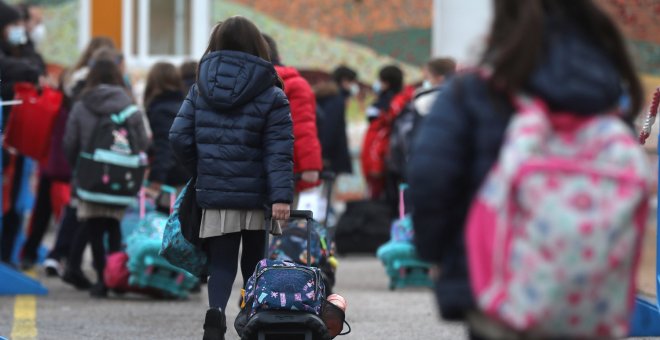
[{"x1": 204, "y1": 233, "x2": 241, "y2": 311}]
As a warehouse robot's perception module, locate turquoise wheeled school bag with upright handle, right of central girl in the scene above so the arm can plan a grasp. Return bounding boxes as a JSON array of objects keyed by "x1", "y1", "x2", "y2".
[{"x1": 376, "y1": 184, "x2": 434, "y2": 290}]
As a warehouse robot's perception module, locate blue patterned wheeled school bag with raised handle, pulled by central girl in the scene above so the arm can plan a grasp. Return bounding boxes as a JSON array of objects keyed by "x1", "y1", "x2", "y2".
[{"x1": 234, "y1": 210, "x2": 330, "y2": 340}]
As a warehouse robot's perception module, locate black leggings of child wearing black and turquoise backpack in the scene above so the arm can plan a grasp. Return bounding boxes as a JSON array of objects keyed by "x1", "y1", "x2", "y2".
[{"x1": 83, "y1": 217, "x2": 121, "y2": 283}]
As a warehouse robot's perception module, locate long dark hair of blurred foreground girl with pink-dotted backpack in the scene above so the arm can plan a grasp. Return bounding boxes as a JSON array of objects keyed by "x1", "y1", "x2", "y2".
[{"x1": 482, "y1": 0, "x2": 644, "y2": 119}]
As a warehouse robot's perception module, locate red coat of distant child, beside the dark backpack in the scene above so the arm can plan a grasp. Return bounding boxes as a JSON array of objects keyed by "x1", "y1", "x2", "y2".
[{"x1": 360, "y1": 86, "x2": 415, "y2": 178}]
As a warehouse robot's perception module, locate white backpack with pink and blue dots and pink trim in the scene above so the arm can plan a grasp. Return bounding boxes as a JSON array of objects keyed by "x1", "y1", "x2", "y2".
[{"x1": 466, "y1": 95, "x2": 652, "y2": 338}]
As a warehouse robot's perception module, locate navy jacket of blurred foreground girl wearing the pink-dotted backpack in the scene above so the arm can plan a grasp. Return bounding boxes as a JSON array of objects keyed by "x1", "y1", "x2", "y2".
[{"x1": 408, "y1": 25, "x2": 622, "y2": 319}]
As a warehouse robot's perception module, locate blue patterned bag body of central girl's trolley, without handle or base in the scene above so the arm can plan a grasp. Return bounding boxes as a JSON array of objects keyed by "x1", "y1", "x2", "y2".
[{"x1": 244, "y1": 259, "x2": 325, "y2": 317}]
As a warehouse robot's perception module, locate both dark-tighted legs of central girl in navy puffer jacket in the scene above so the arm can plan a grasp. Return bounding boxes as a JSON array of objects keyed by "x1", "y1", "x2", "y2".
[{"x1": 204, "y1": 230, "x2": 266, "y2": 311}]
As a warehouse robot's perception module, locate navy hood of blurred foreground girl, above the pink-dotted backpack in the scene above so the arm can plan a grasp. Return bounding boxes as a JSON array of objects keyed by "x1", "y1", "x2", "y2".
[{"x1": 527, "y1": 20, "x2": 623, "y2": 113}]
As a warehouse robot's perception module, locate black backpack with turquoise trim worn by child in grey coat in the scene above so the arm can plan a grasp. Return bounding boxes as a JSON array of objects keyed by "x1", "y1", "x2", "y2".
[{"x1": 76, "y1": 105, "x2": 147, "y2": 206}]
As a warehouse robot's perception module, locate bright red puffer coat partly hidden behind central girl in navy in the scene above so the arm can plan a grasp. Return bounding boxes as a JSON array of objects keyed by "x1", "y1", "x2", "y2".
[{"x1": 275, "y1": 66, "x2": 323, "y2": 191}]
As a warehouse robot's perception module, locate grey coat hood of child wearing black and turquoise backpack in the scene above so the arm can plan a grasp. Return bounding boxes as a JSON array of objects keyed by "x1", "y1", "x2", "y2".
[{"x1": 81, "y1": 85, "x2": 133, "y2": 115}]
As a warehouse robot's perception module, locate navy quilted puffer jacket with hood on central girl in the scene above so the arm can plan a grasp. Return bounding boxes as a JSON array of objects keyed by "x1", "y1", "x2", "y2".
[{"x1": 170, "y1": 51, "x2": 293, "y2": 209}]
